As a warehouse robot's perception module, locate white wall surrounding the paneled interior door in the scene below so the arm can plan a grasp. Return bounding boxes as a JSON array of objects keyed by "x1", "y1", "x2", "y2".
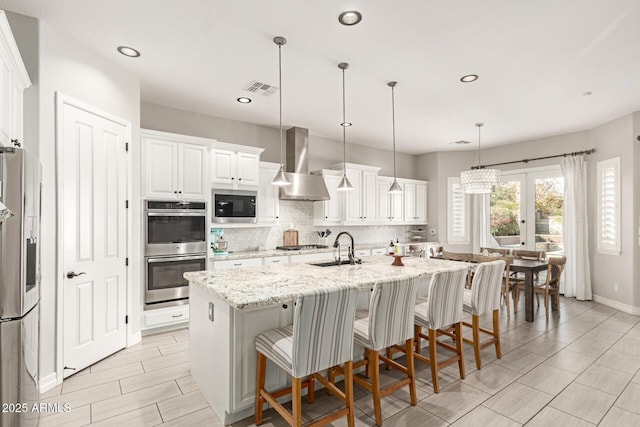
[{"x1": 39, "y1": 21, "x2": 140, "y2": 384}]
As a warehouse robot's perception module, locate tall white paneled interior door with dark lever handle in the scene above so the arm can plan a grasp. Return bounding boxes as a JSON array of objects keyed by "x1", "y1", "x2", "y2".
[{"x1": 58, "y1": 99, "x2": 127, "y2": 377}]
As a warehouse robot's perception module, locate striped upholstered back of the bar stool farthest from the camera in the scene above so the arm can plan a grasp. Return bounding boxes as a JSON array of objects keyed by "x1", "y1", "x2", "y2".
[{"x1": 467, "y1": 260, "x2": 506, "y2": 315}]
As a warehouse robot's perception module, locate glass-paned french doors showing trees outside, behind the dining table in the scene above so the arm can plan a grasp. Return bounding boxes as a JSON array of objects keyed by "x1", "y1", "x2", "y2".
[{"x1": 489, "y1": 167, "x2": 564, "y2": 254}]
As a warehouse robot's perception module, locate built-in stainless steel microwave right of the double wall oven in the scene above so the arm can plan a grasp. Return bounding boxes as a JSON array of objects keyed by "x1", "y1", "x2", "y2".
[{"x1": 211, "y1": 189, "x2": 258, "y2": 224}]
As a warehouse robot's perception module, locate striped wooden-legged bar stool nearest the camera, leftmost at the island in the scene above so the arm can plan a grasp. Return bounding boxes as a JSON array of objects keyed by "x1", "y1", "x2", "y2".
[{"x1": 255, "y1": 285, "x2": 358, "y2": 427}]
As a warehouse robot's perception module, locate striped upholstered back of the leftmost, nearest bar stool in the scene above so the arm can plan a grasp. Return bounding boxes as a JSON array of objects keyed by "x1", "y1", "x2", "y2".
[{"x1": 291, "y1": 285, "x2": 358, "y2": 378}]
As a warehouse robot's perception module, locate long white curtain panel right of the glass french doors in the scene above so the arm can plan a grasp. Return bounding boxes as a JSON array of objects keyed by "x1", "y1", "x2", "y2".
[{"x1": 560, "y1": 155, "x2": 591, "y2": 300}]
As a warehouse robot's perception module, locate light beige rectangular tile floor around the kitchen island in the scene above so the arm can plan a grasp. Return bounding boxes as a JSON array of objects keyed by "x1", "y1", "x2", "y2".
[{"x1": 40, "y1": 299, "x2": 640, "y2": 427}]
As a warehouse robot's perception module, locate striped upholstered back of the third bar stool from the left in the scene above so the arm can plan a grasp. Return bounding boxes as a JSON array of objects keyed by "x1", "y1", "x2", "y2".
[{"x1": 428, "y1": 267, "x2": 467, "y2": 329}]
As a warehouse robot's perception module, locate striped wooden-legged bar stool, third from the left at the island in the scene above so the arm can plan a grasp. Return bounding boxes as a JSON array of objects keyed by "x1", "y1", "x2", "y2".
[{"x1": 407, "y1": 267, "x2": 467, "y2": 393}]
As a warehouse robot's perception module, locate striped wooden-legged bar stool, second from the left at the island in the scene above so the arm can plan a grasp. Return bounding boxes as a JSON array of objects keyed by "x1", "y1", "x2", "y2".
[{"x1": 345, "y1": 279, "x2": 418, "y2": 426}]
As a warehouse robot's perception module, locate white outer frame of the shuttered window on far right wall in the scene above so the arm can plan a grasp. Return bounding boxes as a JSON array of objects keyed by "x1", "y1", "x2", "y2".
[{"x1": 596, "y1": 157, "x2": 622, "y2": 256}]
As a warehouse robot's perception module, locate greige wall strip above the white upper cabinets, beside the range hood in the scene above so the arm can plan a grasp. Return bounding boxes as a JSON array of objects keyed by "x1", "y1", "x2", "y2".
[{"x1": 140, "y1": 102, "x2": 417, "y2": 178}]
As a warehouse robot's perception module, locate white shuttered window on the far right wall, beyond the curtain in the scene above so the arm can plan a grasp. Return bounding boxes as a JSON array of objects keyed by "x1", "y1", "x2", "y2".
[{"x1": 596, "y1": 157, "x2": 621, "y2": 255}]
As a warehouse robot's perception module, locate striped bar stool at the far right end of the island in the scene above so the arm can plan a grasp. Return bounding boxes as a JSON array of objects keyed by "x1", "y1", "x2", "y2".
[{"x1": 462, "y1": 260, "x2": 506, "y2": 369}]
